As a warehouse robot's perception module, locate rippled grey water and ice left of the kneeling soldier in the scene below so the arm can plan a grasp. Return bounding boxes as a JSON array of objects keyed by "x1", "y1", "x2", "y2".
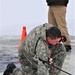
[{"x1": 0, "y1": 36, "x2": 20, "y2": 72}]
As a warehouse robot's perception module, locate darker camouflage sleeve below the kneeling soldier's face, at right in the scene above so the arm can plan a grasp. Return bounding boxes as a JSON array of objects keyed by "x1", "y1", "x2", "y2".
[{"x1": 52, "y1": 44, "x2": 66, "y2": 74}]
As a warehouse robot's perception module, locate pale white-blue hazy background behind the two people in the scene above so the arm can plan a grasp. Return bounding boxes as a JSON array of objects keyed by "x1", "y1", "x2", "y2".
[{"x1": 0, "y1": 0, "x2": 75, "y2": 36}]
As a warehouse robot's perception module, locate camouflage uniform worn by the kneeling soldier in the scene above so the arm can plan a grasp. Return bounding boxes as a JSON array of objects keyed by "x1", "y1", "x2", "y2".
[{"x1": 18, "y1": 23, "x2": 66, "y2": 75}]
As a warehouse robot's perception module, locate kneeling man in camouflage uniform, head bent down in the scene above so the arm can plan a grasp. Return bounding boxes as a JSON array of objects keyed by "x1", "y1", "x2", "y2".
[{"x1": 19, "y1": 23, "x2": 66, "y2": 75}]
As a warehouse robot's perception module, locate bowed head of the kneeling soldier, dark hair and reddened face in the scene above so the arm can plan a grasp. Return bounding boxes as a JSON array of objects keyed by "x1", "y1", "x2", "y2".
[{"x1": 46, "y1": 27, "x2": 61, "y2": 45}]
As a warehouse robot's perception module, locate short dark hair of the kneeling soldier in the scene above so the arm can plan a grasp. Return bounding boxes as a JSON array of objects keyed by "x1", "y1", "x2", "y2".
[{"x1": 46, "y1": 27, "x2": 61, "y2": 39}]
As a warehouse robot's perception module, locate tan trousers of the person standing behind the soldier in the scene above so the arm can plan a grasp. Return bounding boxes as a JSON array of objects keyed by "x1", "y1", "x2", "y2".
[{"x1": 48, "y1": 6, "x2": 71, "y2": 45}]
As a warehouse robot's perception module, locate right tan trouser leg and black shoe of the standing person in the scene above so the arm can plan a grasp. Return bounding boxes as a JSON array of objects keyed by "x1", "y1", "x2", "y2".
[{"x1": 52, "y1": 6, "x2": 71, "y2": 51}]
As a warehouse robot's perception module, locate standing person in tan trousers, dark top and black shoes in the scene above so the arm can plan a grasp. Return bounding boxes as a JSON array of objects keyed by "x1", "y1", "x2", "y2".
[{"x1": 46, "y1": 0, "x2": 71, "y2": 51}]
